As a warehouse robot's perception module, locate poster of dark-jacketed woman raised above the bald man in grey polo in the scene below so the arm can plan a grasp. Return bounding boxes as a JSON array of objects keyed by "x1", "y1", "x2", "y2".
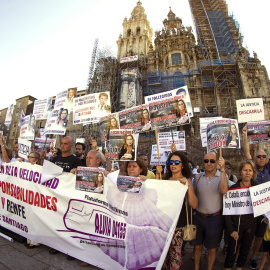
[{"x1": 207, "y1": 118, "x2": 240, "y2": 152}]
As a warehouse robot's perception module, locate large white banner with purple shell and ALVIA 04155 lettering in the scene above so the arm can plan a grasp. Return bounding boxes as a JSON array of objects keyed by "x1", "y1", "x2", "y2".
[{"x1": 0, "y1": 162, "x2": 187, "y2": 270}]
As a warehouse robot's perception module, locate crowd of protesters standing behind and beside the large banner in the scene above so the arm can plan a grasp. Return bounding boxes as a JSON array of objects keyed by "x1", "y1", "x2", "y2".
[{"x1": 0, "y1": 126, "x2": 270, "y2": 270}]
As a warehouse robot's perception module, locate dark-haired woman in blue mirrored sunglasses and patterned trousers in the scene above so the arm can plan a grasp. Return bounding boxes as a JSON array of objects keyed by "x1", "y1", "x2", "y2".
[{"x1": 157, "y1": 151, "x2": 198, "y2": 269}]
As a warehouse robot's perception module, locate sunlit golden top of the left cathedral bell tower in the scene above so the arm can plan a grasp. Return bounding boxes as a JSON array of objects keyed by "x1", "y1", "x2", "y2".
[{"x1": 117, "y1": 1, "x2": 153, "y2": 61}]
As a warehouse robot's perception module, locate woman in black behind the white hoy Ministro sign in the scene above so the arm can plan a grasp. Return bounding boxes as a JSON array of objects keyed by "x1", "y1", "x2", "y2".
[{"x1": 224, "y1": 160, "x2": 257, "y2": 270}]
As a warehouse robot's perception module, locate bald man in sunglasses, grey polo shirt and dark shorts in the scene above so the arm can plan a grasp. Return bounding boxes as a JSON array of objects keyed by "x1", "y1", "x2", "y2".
[{"x1": 191, "y1": 152, "x2": 228, "y2": 270}]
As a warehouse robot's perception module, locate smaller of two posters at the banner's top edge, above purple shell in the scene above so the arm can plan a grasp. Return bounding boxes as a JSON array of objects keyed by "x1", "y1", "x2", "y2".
[{"x1": 117, "y1": 175, "x2": 143, "y2": 193}]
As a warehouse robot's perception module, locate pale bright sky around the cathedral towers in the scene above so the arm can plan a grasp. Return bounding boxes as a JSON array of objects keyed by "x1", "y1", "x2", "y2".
[{"x1": 0, "y1": 0, "x2": 270, "y2": 109}]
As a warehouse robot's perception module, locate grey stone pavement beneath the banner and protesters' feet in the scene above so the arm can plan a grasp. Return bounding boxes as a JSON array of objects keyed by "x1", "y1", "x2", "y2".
[{"x1": 0, "y1": 233, "x2": 267, "y2": 270}]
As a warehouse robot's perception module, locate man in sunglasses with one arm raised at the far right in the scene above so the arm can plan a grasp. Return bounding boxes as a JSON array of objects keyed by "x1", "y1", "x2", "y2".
[{"x1": 242, "y1": 126, "x2": 270, "y2": 269}]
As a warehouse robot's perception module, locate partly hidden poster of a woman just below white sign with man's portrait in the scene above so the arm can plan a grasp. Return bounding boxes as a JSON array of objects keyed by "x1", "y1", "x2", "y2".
[{"x1": 99, "y1": 113, "x2": 120, "y2": 142}]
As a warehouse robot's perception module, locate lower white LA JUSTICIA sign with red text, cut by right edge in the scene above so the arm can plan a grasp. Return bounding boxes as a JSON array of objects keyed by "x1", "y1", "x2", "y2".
[{"x1": 249, "y1": 182, "x2": 270, "y2": 217}]
